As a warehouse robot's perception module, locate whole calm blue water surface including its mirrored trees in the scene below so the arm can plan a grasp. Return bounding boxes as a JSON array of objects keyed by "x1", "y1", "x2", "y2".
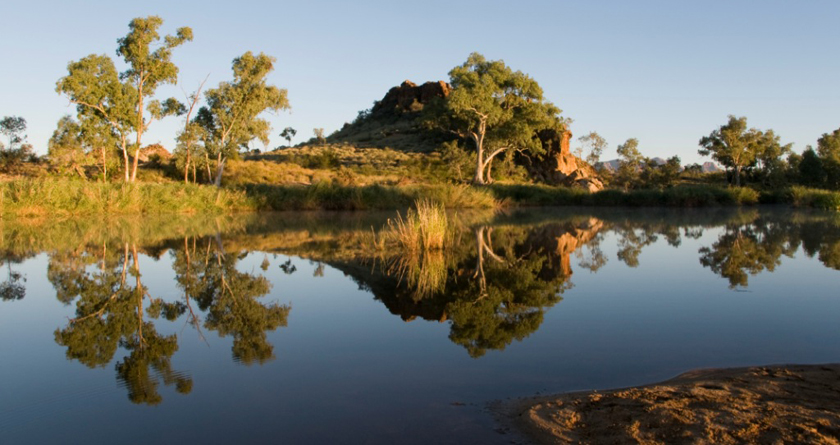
[{"x1": 0, "y1": 208, "x2": 840, "y2": 444}]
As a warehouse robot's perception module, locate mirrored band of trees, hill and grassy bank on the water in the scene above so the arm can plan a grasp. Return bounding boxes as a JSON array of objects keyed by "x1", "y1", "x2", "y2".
[{"x1": 0, "y1": 209, "x2": 840, "y2": 405}]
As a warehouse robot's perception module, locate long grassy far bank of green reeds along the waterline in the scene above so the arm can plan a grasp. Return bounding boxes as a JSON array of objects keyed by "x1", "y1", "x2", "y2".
[{"x1": 0, "y1": 178, "x2": 840, "y2": 216}]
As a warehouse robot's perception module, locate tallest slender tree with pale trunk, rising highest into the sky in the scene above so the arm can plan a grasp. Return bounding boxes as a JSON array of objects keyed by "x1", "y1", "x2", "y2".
[{"x1": 117, "y1": 16, "x2": 193, "y2": 181}]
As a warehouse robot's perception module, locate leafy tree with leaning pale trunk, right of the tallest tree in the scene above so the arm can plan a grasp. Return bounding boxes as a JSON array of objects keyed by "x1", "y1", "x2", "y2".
[{"x1": 196, "y1": 51, "x2": 289, "y2": 186}]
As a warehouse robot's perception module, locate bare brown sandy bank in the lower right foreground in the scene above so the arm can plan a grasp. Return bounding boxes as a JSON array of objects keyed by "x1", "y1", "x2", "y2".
[{"x1": 496, "y1": 364, "x2": 840, "y2": 444}]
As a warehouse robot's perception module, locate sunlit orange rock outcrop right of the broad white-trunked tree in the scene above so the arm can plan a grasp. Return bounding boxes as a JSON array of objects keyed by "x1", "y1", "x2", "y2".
[{"x1": 524, "y1": 130, "x2": 604, "y2": 192}]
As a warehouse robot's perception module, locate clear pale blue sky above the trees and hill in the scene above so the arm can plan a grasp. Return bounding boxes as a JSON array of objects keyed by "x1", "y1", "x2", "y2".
[{"x1": 0, "y1": 0, "x2": 840, "y2": 163}]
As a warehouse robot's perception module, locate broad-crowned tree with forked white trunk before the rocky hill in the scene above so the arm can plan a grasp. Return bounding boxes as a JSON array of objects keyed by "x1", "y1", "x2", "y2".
[{"x1": 424, "y1": 53, "x2": 564, "y2": 184}]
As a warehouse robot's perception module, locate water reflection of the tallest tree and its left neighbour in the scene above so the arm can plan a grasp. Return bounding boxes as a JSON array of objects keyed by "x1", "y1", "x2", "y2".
[{"x1": 55, "y1": 243, "x2": 192, "y2": 405}]
